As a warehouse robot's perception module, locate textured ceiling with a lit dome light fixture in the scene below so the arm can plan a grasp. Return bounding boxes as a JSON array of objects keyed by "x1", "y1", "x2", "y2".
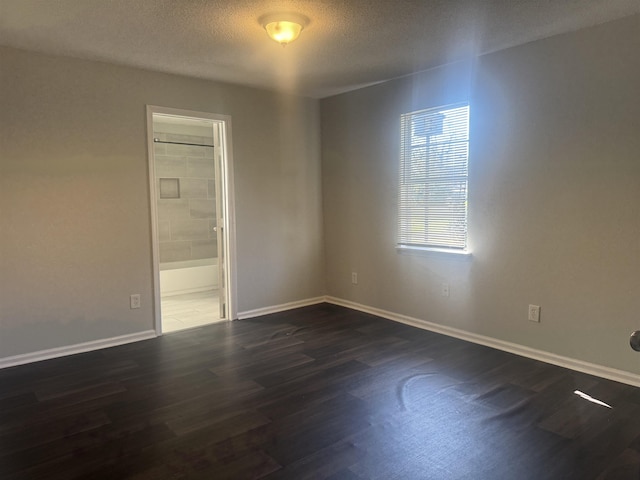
[{"x1": 0, "y1": 0, "x2": 640, "y2": 98}]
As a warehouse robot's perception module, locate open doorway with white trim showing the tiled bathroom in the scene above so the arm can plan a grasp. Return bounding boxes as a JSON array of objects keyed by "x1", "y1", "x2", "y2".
[{"x1": 147, "y1": 106, "x2": 235, "y2": 334}]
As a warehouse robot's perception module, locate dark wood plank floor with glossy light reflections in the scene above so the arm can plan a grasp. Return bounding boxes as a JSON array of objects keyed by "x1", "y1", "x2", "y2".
[{"x1": 0, "y1": 304, "x2": 640, "y2": 480}]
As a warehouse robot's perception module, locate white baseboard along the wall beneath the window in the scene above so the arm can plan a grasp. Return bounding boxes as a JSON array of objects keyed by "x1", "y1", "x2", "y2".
[{"x1": 326, "y1": 296, "x2": 640, "y2": 387}]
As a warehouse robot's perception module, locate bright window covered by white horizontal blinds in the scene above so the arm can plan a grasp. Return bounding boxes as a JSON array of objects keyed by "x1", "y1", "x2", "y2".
[{"x1": 398, "y1": 103, "x2": 469, "y2": 252}]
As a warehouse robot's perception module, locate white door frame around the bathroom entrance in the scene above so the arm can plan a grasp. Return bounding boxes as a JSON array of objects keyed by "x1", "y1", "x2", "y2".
[{"x1": 147, "y1": 105, "x2": 238, "y2": 335}]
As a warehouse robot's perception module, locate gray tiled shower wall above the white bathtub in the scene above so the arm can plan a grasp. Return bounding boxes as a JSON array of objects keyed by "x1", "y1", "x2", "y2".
[{"x1": 154, "y1": 132, "x2": 218, "y2": 263}]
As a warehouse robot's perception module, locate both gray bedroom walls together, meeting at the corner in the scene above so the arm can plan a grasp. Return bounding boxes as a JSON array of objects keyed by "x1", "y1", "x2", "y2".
[{"x1": 0, "y1": 16, "x2": 640, "y2": 373}]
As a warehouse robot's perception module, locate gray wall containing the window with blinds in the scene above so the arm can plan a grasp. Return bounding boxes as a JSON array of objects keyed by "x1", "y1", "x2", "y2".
[{"x1": 321, "y1": 16, "x2": 640, "y2": 373}]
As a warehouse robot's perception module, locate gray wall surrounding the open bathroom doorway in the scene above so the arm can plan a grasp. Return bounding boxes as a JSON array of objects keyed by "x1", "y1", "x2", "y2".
[{"x1": 0, "y1": 48, "x2": 324, "y2": 358}]
